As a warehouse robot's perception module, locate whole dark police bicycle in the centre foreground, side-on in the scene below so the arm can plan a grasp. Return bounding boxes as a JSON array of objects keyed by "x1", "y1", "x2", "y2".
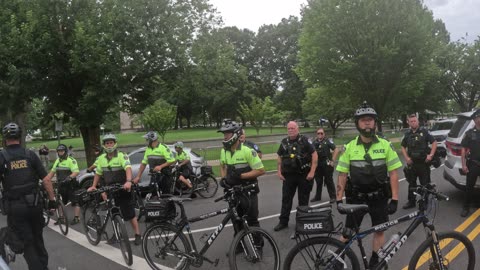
[{"x1": 142, "y1": 184, "x2": 280, "y2": 270}]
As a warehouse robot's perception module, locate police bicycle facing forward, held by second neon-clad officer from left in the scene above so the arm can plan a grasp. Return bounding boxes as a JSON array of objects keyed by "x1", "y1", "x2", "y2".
[{"x1": 82, "y1": 184, "x2": 133, "y2": 265}]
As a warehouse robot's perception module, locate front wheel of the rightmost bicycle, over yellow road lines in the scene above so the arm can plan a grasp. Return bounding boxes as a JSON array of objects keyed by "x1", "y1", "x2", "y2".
[{"x1": 408, "y1": 231, "x2": 475, "y2": 270}]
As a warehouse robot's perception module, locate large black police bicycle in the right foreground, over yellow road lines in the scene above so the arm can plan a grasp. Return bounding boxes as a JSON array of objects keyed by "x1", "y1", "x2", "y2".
[{"x1": 283, "y1": 185, "x2": 475, "y2": 270}]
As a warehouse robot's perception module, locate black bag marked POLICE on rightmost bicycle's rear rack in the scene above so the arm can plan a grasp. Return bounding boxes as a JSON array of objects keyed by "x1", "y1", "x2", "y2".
[{"x1": 295, "y1": 206, "x2": 334, "y2": 234}]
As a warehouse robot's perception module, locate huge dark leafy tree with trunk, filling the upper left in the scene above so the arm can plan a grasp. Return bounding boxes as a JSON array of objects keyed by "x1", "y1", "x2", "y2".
[{"x1": 0, "y1": 0, "x2": 216, "y2": 164}]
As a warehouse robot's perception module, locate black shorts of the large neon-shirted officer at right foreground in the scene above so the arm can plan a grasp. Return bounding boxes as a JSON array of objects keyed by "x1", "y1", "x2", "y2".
[{"x1": 345, "y1": 197, "x2": 388, "y2": 229}]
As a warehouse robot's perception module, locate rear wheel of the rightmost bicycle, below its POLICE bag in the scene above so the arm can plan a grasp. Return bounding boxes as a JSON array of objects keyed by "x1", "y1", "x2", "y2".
[{"x1": 283, "y1": 236, "x2": 360, "y2": 270}]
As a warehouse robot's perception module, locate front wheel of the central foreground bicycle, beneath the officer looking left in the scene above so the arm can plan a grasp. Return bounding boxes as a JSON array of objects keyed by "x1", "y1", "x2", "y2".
[{"x1": 228, "y1": 227, "x2": 280, "y2": 270}]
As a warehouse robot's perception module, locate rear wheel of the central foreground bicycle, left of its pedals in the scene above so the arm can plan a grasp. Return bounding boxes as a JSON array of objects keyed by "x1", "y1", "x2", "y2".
[{"x1": 142, "y1": 223, "x2": 191, "y2": 270}]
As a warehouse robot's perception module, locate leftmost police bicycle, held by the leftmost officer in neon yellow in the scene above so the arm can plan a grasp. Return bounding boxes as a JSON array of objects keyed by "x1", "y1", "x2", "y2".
[{"x1": 40, "y1": 181, "x2": 68, "y2": 235}]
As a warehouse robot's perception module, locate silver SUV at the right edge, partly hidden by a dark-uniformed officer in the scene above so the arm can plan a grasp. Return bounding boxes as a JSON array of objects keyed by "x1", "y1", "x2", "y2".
[{"x1": 443, "y1": 111, "x2": 480, "y2": 190}]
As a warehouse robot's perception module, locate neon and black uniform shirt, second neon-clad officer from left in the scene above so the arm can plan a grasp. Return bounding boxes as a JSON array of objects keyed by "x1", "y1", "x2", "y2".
[{"x1": 95, "y1": 151, "x2": 132, "y2": 185}]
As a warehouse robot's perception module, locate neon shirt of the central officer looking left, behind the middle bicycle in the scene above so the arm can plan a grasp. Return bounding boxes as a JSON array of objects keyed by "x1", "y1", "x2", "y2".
[{"x1": 220, "y1": 144, "x2": 263, "y2": 185}]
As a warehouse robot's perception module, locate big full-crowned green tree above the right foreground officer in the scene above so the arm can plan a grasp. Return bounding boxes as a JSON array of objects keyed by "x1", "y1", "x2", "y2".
[{"x1": 297, "y1": 0, "x2": 442, "y2": 130}]
